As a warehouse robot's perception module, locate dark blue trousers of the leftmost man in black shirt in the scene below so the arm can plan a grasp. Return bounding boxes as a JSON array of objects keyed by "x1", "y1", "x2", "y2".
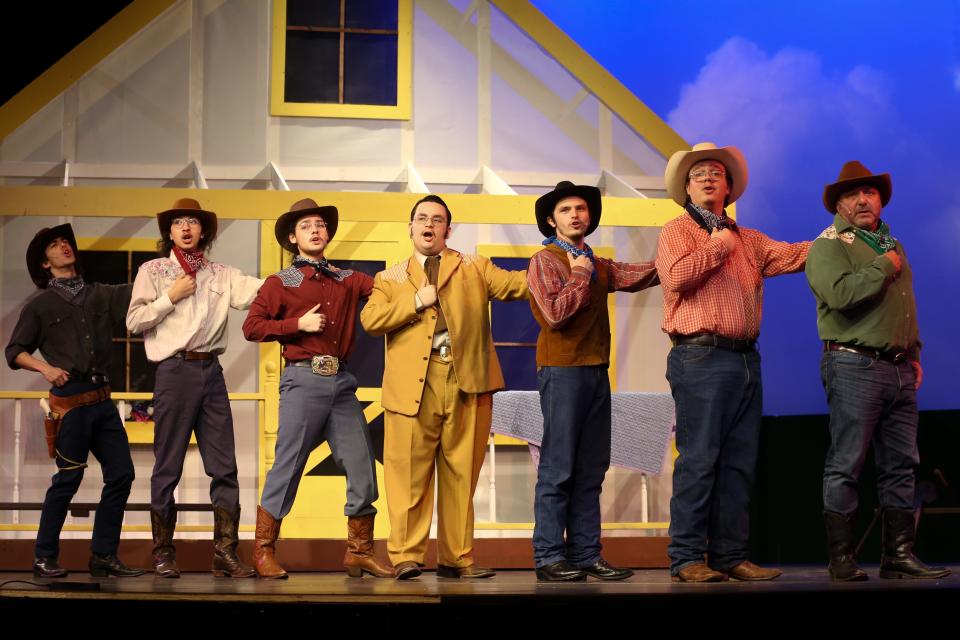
[{"x1": 35, "y1": 382, "x2": 134, "y2": 557}]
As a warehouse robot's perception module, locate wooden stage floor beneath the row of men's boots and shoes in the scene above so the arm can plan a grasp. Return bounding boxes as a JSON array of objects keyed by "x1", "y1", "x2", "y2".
[{"x1": 0, "y1": 565, "x2": 960, "y2": 605}]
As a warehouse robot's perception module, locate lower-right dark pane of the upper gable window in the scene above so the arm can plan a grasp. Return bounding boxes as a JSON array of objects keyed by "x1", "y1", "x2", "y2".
[{"x1": 343, "y1": 33, "x2": 397, "y2": 105}]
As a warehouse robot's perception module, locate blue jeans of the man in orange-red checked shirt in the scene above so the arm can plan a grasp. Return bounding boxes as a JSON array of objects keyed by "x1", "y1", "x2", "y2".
[{"x1": 667, "y1": 345, "x2": 763, "y2": 575}]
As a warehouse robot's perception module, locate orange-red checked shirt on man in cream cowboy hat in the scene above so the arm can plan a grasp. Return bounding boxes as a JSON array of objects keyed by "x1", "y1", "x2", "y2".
[{"x1": 656, "y1": 214, "x2": 810, "y2": 340}]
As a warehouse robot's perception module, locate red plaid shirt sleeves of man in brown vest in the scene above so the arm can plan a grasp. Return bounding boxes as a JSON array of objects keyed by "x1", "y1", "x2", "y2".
[{"x1": 527, "y1": 242, "x2": 660, "y2": 329}]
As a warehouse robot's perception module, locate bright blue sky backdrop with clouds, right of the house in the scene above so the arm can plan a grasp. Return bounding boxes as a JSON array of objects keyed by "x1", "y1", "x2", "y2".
[{"x1": 533, "y1": 0, "x2": 960, "y2": 415}]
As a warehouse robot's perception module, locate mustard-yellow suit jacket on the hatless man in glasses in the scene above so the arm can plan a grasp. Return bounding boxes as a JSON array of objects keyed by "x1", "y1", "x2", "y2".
[{"x1": 360, "y1": 249, "x2": 527, "y2": 416}]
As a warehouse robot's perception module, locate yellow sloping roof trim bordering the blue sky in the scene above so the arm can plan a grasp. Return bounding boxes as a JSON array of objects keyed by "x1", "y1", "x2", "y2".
[{"x1": 490, "y1": 0, "x2": 690, "y2": 158}]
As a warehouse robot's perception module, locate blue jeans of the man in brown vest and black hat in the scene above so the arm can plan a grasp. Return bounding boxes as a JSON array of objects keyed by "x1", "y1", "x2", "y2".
[{"x1": 533, "y1": 365, "x2": 611, "y2": 567}]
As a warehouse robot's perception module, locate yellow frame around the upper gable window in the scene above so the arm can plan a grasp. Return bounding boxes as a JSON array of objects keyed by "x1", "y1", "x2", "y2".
[{"x1": 270, "y1": 0, "x2": 413, "y2": 120}]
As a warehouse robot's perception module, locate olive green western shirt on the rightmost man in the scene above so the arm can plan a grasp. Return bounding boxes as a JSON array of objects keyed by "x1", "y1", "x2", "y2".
[{"x1": 806, "y1": 214, "x2": 920, "y2": 360}]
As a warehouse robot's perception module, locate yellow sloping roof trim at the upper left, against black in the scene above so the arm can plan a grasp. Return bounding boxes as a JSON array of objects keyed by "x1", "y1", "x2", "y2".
[{"x1": 0, "y1": 0, "x2": 177, "y2": 140}]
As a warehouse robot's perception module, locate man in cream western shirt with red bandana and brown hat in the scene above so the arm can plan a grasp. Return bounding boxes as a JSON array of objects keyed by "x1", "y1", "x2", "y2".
[{"x1": 127, "y1": 198, "x2": 263, "y2": 578}]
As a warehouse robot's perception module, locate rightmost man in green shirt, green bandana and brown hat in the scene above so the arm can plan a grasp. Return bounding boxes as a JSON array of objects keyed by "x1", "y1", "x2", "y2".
[{"x1": 806, "y1": 160, "x2": 950, "y2": 582}]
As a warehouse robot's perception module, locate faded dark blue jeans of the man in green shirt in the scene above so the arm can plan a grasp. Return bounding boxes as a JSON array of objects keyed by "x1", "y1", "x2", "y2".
[{"x1": 820, "y1": 351, "x2": 920, "y2": 516}]
